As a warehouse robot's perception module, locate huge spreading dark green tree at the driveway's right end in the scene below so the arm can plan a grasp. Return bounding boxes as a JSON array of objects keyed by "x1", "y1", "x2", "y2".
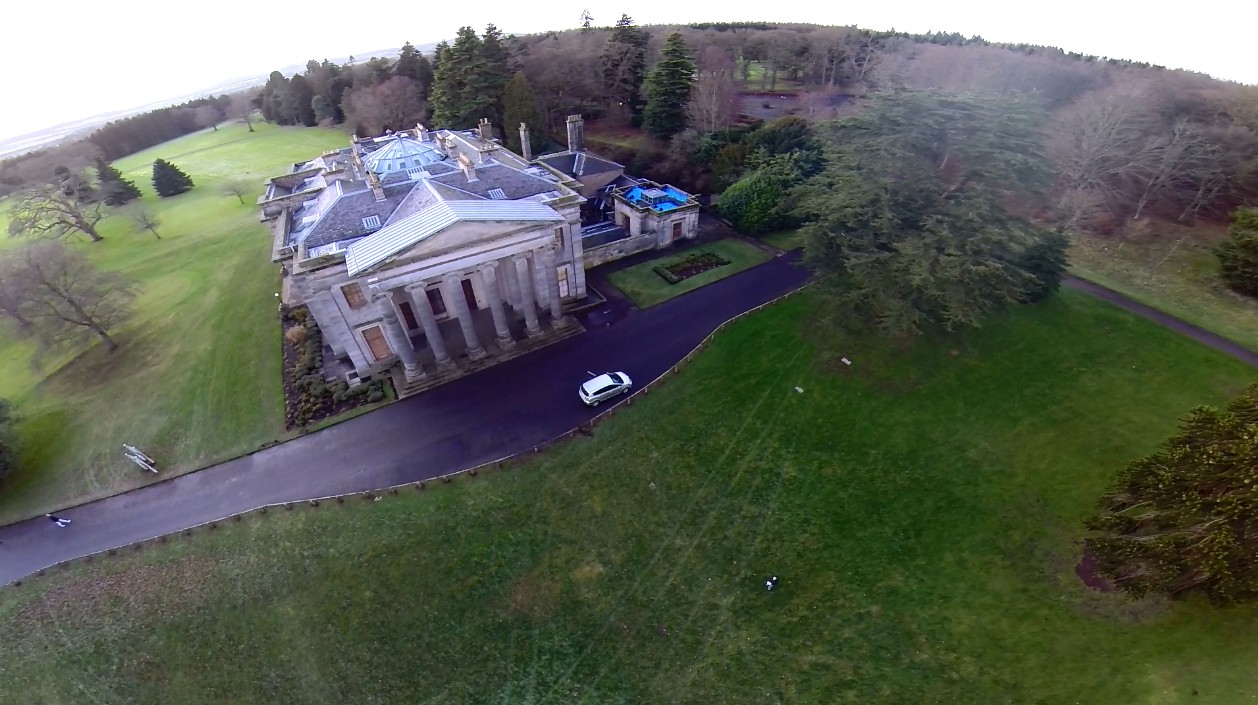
[{"x1": 794, "y1": 93, "x2": 1066, "y2": 337}]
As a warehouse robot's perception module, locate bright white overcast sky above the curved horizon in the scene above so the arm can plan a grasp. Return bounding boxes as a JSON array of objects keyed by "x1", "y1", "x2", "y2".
[{"x1": 0, "y1": 0, "x2": 1258, "y2": 138}]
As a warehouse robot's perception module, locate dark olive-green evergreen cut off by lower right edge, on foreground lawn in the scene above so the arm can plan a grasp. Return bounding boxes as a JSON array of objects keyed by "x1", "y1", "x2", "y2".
[{"x1": 1084, "y1": 384, "x2": 1258, "y2": 603}]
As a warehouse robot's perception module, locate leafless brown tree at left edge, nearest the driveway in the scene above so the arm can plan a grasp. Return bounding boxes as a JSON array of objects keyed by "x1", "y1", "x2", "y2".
[{"x1": 9, "y1": 240, "x2": 136, "y2": 351}]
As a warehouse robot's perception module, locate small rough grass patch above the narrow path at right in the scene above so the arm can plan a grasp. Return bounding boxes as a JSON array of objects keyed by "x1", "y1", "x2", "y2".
[{"x1": 1069, "y1": 227, "x2": 1258, "y2": 350}]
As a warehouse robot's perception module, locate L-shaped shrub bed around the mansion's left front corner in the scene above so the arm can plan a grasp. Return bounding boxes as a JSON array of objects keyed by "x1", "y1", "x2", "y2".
[{"x1": 279, "y1": 306, "x2": 385, "y2": 429}]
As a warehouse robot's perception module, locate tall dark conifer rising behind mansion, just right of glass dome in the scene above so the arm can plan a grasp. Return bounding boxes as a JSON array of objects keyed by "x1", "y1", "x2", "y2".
[{"x1": 431, "y1": 26, "x2": 496, "y2": 130}]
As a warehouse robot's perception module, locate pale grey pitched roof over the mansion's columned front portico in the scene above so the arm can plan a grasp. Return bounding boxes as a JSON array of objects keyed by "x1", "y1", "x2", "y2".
[{"x1": 345, "y1": 200, "x2": 564, "y2": 277}]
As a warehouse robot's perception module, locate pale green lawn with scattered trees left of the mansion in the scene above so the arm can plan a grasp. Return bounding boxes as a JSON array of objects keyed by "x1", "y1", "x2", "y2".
[{"x1": 0, "y1": 123, "x2": 346, "y2": 522}]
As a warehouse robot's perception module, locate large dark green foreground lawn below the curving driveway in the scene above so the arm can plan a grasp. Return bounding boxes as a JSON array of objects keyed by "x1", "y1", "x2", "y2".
[{"x1": 0, "y1": 292, "x2": 1258, "y2": 705}]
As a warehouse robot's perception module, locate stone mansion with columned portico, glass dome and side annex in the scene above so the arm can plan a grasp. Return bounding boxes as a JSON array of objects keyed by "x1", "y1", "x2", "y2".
[{"x1": 258, "y1": 116, "x2": 698, "y2": 394}]
